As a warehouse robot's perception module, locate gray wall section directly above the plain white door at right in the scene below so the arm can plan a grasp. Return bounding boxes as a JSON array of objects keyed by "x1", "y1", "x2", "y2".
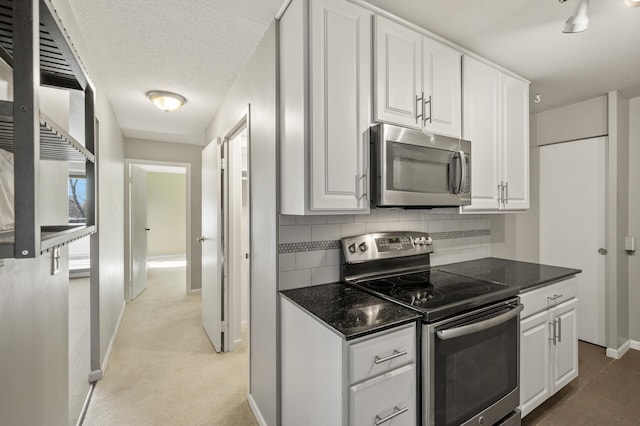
[{"x1": 532, "y1": 96, "x2": 609, "y2": 145}]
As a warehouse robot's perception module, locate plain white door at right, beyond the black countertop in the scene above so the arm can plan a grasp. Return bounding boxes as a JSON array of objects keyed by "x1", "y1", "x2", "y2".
[{"x1": 540, "y1": 137, "x2": 607, "y2": 346}]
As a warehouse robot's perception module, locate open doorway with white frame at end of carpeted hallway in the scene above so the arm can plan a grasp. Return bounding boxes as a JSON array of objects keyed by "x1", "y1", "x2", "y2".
[{"x1": 125, "y1": 160, "x2": 192, "y2": 301}]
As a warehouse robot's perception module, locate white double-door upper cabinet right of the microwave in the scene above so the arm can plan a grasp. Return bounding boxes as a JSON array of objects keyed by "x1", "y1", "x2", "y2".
[{"x1": 462, "y1": 56, "x2": 529, "y2": 212}]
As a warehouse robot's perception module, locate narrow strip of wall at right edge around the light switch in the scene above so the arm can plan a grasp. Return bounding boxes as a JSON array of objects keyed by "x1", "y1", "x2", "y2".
[{"x1": 629, "y1": 97, "x2": 640, "y2": 342}]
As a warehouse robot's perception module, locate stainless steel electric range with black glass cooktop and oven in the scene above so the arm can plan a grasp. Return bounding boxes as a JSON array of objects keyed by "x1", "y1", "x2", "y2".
[{"x1": 342, "y1": 232, "x2": 522, "y2": 426}]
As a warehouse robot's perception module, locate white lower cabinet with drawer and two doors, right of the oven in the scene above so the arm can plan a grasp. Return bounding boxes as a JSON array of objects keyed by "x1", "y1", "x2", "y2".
[{"x1": 520, "y1": 278, "x2": 578, "y2": 417}]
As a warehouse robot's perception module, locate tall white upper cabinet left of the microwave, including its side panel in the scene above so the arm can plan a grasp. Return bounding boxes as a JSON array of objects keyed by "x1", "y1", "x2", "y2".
[{"x1": 280, "y1": 0, "x2": 372, "y2": 215}]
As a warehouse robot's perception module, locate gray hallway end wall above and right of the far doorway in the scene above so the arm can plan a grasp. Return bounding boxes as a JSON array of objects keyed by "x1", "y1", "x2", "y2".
[{"x1": 124, "y1": 139, "x2": 202, "y2": 290}]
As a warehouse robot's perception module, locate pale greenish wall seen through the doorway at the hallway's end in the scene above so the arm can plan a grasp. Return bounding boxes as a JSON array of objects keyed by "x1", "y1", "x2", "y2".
[{"x1": 147, "y1": 172, "x2": 187, "y2": 256}]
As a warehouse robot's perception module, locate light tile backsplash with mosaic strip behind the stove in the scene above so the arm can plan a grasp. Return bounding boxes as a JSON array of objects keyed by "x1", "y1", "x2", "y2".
[{"x1": 278, "y1": 209, "x2": 491, "y2": 290}]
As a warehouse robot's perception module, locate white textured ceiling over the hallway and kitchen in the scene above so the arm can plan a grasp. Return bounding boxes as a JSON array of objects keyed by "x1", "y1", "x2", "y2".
[{"x1": 68, "y1": 0, "x2": 640, "y2": 144}]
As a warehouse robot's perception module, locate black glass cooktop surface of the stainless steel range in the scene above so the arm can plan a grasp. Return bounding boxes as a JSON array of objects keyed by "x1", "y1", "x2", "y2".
[{"x1": 350, "y1": 270, "x2": 518, "y2": 322}]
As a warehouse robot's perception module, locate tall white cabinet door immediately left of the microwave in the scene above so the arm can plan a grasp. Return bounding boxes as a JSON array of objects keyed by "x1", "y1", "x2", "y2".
[{"x1": 309, "y1": 0, "x2": 371, "y2": 211}]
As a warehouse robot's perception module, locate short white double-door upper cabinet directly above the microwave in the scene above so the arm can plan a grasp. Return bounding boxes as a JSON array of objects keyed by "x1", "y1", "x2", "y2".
[{"x1": 374, "y1": 16, "x2": 461, "y2": 137}]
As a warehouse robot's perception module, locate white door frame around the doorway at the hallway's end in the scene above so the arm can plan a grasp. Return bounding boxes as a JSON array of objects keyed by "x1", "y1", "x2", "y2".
[{"x1": 124, "y1": 158, "x2": 194, "y2": 302}]
